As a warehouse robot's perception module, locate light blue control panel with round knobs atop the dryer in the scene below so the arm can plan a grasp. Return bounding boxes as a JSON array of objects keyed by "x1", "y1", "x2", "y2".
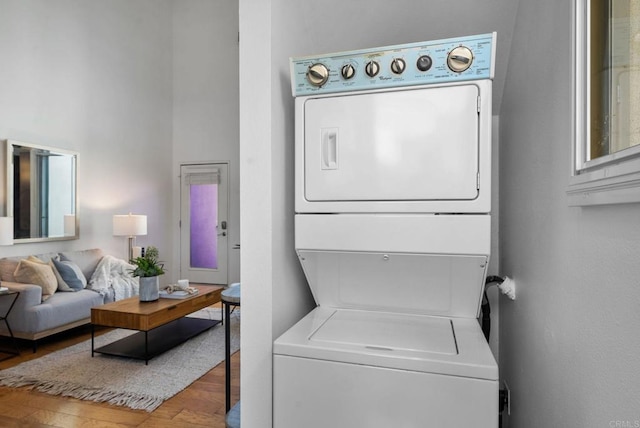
[{"x1": 290, "y1": 32, "x2": 496, "y2": 97}]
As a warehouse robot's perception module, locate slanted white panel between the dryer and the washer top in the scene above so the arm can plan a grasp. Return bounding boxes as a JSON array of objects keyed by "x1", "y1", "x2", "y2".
[{"x1": 298, "y1": 250, "x2": 487, "y2": 319}]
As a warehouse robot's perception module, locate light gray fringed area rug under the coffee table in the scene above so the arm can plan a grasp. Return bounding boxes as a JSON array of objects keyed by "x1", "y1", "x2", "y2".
[{"x1": 0, "y1": 308, "x2": 240, "y2": 412}]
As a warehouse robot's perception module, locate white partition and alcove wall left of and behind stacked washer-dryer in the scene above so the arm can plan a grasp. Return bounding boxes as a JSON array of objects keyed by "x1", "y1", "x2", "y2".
[{"x1": 240, "y1": 0, "x2": 517, "y2": 428}]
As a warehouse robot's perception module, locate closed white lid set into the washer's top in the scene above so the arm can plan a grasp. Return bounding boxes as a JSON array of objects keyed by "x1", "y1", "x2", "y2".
[{"x1": 309, "y1": 311, "x2": 458, "y2": 355}]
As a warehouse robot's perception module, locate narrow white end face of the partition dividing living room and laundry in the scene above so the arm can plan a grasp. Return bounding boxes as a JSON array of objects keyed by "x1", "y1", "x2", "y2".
[{"x1": 239, "y1": 0, "x2": 278, "y2": 427}]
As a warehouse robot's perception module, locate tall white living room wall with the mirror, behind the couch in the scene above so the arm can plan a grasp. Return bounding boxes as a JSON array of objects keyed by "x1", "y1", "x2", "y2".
[{"x1": 0, "y1": 0, "x2": 172, "y2": 257}]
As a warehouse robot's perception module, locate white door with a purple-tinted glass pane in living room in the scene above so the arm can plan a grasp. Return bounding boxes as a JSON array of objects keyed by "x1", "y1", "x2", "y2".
[{"x1": 180, "y1": 163, "x2": 229, "y2": 285}]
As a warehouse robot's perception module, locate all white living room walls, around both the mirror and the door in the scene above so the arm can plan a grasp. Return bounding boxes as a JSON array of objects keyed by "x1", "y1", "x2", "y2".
[{"x1": 0, "y1": 0, "x2": 240, "y2": 288}]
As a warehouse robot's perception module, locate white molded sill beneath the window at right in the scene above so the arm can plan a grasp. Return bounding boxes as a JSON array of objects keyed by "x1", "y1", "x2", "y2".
[{"x1": 567, "y1": 159, "x2": 640, "y2": 207}]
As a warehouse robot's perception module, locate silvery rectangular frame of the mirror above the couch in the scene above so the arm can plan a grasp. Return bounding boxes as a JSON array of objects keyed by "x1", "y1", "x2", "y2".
[{"x1": 5, "y1": 140, "x2": 80, "y2": 244}]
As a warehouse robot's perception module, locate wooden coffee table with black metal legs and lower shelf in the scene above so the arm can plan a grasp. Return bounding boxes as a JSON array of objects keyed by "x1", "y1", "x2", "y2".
[{"x1": 91, "y1": 284, "x2": 224, "y2": 364}]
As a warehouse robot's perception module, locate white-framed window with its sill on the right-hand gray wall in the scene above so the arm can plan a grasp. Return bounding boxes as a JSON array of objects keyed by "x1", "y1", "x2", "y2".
[{"x1": 568, "y1": 0, "x2": 640, "y2": 205}]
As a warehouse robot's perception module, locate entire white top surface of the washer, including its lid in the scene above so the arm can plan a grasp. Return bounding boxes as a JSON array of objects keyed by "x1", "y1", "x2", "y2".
[{"x1": 273, "y1": 307, "x2": 498, "y2": 381}]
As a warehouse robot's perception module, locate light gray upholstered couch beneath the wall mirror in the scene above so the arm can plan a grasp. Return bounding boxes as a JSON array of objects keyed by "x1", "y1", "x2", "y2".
[{"x1": 0, "y1": 249, "x2": 124, "y2": 350}]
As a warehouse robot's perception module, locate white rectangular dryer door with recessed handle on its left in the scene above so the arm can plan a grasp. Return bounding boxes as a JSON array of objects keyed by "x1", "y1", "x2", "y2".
[{"x1": 304, "y1": 84, "x2": 479, "y2": 202}]
